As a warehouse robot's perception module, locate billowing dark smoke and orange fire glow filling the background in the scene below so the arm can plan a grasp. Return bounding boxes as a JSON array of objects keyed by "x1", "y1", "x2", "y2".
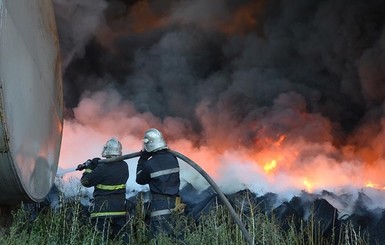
[{"x1": 54, "y1": 0, "x2": 385, "y2": 211}]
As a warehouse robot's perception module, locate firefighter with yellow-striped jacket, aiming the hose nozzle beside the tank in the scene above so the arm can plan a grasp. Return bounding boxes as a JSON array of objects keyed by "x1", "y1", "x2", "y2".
[{"x1": 77, "y1": 138, "x2": 129, "y2": 242}]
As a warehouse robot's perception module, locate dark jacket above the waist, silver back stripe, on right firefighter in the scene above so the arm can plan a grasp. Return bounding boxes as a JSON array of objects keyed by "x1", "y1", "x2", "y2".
[{"x1": 136, "y1": 149, "x2": 180, "y2": 197}]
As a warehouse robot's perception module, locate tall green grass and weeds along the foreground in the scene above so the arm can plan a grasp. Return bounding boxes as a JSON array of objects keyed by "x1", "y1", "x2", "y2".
[{"x1": 0, "y1": 191, "x2": 369, "y2": 245}]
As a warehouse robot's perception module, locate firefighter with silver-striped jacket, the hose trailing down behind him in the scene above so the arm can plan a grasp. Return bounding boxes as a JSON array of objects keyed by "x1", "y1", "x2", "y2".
[{"x1": 136, "y1": 128, "x2": 184, "y2": 238}]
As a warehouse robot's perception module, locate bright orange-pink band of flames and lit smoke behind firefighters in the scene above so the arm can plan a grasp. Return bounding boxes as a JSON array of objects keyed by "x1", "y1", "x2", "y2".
[{"x1": 60, "y1": 92, "x2": 383, "y2": 198}]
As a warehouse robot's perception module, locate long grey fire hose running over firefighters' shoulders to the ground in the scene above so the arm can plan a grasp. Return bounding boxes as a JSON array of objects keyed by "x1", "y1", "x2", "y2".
[{"x1": 99, "y1": 150, "x2": 254, "y2": 245}]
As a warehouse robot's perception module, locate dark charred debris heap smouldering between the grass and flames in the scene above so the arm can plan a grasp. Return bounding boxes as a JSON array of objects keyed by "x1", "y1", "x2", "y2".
[{"x1": 27, "y1": 184, "x2": 385, "y2": 244}]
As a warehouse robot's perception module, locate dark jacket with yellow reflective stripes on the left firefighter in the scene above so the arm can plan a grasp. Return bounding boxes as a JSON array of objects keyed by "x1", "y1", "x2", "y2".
[{"x1": 80, "y1": 161, "x2": 129, "y2": 218}]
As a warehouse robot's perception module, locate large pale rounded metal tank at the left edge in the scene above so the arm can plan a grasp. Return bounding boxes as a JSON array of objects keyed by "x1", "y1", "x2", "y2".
[{"x1": 0, "y1": 0, "x2": 63, "y2": 205}]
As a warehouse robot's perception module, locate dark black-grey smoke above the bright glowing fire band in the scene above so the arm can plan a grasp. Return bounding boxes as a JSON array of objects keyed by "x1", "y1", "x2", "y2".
[{"x1": 54, "y1": 0, "x2": 385, "y2": 151}]
